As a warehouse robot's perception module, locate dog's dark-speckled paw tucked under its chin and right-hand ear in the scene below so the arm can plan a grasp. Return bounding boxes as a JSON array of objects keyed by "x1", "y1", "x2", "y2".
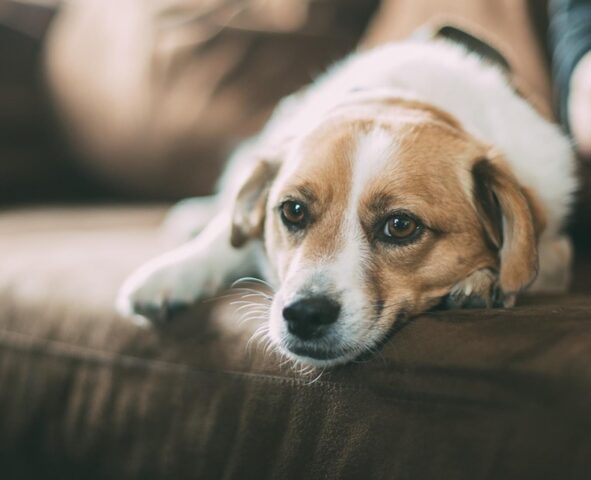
[{"x1": 444, "y1": 268, "x2": 506, "y2": 309}]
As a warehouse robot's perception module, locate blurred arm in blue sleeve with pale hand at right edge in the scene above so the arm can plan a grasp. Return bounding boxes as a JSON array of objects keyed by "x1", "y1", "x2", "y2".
[{"x1": 550, "y1": 0, "x2": 591, "y2": 158}]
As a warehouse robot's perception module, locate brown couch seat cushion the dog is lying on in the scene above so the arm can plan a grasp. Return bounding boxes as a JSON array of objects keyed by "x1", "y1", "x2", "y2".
[{"x1": 0, "y1": 207, "x2": 591, "y2": 479}]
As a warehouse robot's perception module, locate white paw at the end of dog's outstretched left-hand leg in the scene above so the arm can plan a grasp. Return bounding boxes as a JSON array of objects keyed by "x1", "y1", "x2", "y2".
[{"x1": 116, "y1": 255, "x2": 221, "y2": 324}]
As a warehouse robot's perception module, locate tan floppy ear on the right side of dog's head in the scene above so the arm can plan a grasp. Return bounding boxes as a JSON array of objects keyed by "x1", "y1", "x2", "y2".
[{"x1": 472, "y1": 155, "x2": 544, "y2": 306}]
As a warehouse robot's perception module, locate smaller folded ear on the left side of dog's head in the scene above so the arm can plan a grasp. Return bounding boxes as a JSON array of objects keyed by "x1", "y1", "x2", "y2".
[{"x1": 230, "y1": 160, "x2": 279, "y2": 248}]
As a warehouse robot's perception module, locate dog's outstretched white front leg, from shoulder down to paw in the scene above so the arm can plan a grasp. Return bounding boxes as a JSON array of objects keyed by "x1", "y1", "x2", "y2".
[{"x1": 117, "y1": 211, "x2": 258, "y2": 322}]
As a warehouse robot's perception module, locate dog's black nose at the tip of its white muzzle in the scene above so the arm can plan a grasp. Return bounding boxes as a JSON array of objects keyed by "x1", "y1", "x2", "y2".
[{"x1": 283, "y1": 297, "x2": 341, "y2": 340}]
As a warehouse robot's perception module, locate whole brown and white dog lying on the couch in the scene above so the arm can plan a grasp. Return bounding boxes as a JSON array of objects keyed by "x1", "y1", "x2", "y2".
[{"x1": 117, "y1": 41, "x2": 576, "y2": 366}]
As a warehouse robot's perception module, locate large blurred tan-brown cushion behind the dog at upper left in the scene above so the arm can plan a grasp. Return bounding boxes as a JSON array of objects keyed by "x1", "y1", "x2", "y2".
[{"x1": 46, "y1": 0, "x2": 375, "y2": 198}]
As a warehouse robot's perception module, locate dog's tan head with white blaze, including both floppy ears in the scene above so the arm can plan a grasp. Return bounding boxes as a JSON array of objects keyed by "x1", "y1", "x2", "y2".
[{"x1": 232, "y1": 100, "x2": 540, "y2": 366}]
